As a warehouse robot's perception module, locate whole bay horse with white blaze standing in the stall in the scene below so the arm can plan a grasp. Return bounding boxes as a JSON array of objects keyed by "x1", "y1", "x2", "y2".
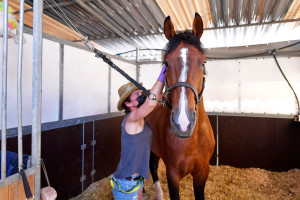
[{"x1": 146, "y1": 13, "x2": 215, "y2": 200}]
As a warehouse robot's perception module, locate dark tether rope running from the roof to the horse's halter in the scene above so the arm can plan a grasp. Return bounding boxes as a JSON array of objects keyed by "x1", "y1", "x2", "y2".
[{"x1": 44, "y1": 0, "x2": 165, "y2": 103}]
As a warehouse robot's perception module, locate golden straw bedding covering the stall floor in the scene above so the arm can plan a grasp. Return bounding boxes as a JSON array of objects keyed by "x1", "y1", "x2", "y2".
[{"x1": 72, "y1": 162, "x2": 300, "y2": 200}]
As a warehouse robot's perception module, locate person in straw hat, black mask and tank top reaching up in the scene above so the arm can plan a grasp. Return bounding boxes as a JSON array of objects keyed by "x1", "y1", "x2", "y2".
[{"x1": 110, "y1": 65, "x2": 165, "y2": 200}]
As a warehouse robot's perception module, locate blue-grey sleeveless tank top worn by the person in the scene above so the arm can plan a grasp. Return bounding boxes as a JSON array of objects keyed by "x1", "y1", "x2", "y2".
[{"x1": 113, "y1": 113, "x2": 152, "y2": 180}]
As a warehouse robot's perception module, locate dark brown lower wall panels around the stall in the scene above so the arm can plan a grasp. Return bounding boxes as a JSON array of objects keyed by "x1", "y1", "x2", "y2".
[{"x1": 2, "y1": 113, "x2": 300, "y2": 200}]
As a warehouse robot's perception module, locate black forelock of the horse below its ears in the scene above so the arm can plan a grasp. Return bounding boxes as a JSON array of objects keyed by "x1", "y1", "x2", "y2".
[{"x1": 164, "y1": 31, "x2": 205, "y2": 58}]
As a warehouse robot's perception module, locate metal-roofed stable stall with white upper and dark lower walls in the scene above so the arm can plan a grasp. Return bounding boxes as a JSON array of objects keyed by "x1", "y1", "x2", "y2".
[{"x1": 0, "y1": 0, "x2": 300, "y2": 199}]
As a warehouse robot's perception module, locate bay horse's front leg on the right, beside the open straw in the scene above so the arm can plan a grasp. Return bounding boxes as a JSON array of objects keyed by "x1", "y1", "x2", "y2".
[{"x1": 192, "y1": 165, "x2": 209, "y2": 200}]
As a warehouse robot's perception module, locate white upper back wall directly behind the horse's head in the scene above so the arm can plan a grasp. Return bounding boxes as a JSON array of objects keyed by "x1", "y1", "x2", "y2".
[{"x1": 140, "y1": 57, "x2": 300, "y2": 115}]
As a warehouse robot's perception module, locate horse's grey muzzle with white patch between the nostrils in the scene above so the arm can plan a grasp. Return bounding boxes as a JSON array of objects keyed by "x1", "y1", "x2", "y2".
[{"x1": 170, "y1": 110, "x2": 196, "y2": 138}]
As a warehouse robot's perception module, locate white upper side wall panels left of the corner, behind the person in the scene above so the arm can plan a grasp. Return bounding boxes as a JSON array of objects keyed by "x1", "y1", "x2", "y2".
[{"x1": 0, "y1": 34, "x2": 136, "y2": 128}]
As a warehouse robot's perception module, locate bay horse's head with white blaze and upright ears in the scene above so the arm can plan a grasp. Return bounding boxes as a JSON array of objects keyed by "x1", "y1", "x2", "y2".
[{"x1": 164, "y1": 13, "x2": 205, "y2": 138}]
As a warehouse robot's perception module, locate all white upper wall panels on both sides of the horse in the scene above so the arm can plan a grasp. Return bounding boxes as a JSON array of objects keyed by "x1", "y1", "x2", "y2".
[{"x1": 0, "y1": 34, "x2": 300, "y2": 128}]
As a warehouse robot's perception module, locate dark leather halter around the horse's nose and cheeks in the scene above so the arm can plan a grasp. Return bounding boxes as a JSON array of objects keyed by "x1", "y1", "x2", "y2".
[{"x1": 162, "y1": 76, "x2": 205, "y2": 110}]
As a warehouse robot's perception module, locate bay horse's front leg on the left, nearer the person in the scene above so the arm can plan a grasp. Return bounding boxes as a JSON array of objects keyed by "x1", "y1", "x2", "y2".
[{"x1": 167, "y1": 167, "x2": 181, "y2": 200}]
